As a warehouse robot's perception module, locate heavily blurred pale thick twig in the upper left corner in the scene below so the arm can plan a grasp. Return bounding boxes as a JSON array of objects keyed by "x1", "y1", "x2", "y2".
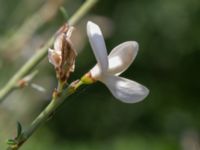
[{"x1": 0, "y1": 0, "x2": 63, "y2": 57}]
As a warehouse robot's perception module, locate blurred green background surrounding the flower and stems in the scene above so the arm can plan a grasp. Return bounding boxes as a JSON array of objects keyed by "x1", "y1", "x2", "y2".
[{"x1": 0, "y1": 0, "x2": 200, "y2": 150}]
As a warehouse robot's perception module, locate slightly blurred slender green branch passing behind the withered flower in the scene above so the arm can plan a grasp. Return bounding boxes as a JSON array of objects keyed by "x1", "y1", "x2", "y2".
[{"x1": 0, "y1": 0, "x2": 97, "y2": 102}]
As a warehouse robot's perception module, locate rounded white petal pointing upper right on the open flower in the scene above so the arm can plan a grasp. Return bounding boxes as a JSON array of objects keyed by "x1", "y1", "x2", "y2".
[{"x1": 108, "y1": 41, "x2": 139, "y2": 75}]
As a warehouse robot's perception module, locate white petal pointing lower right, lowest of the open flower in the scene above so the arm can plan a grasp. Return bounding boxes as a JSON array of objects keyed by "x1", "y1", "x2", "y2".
[{"x1": 101, "y1": 75, "x2": 149, "y2": 103}]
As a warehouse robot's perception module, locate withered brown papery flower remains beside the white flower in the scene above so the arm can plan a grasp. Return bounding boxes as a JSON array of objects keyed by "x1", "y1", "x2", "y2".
[{"x1": 48, "y1": 25, "x2": 77, "y2": 82}]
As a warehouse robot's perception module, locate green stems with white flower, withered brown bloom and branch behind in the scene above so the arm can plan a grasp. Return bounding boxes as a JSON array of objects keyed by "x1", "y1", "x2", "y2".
[{"x1": 0, "y1": 0, "x2": 149, "y2": 150}]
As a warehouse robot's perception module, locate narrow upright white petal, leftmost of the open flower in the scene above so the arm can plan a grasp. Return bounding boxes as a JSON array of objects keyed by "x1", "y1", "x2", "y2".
[{"x1": 87, "y1": 21, "x2": 108, "y2": 73}]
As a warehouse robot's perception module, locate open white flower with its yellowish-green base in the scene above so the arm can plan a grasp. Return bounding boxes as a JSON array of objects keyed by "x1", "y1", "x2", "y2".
[{"x1": 81, "y1": 21, "x2": 149, "y2": 103}]
